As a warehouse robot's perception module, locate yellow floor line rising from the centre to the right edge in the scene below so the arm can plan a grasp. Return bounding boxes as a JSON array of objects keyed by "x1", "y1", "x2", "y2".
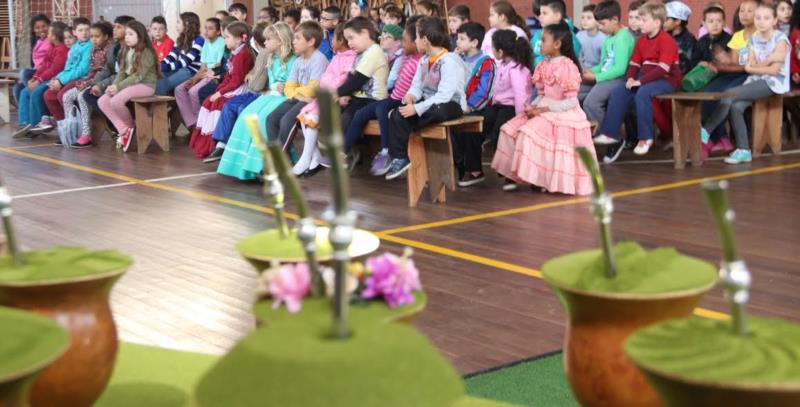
[{"x1": 381, "y1": 162, "x2": 800, "y2": 234}]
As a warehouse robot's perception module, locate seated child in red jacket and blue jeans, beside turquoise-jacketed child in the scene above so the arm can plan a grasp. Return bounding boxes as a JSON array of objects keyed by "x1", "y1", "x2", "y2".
[{"x1": 12, "y1": 21, "x2": 69, "y2": 138}]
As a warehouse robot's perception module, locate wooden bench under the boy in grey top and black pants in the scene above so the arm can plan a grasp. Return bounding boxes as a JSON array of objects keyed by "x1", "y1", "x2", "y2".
[{"x1": 364, "y1": 116, "x2": 483, "y2": 207}]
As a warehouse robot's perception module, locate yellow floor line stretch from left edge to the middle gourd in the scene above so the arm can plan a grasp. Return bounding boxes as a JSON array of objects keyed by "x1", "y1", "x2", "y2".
[{"x1": 0, "y1": 147, "x2": 297, "y2": 219}]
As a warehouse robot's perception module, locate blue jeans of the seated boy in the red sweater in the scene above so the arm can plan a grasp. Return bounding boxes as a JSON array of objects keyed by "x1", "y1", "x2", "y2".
[{"x1": 597, "y1": 79, "x2": 675, "y2": 140}]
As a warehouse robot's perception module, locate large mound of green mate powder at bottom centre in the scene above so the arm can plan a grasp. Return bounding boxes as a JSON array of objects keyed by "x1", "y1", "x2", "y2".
[{"x1": 197, "y1": 322, "x2": 463, "y2": 407}]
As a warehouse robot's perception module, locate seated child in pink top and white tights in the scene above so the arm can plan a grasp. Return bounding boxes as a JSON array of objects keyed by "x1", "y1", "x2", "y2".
[{"x1": 292, "y1": 24, "x2": 358, "y2": 176}]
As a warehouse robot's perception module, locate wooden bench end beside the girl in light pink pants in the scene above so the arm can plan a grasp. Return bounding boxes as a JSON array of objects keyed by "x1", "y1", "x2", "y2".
[{"x1": 131, "y1": 96, "x2": 175, "y2": 154}]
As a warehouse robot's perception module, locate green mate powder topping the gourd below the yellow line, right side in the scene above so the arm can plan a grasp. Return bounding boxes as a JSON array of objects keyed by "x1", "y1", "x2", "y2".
[{"x1": 542, "y1": 242, "x2": 717, "y2": 294}]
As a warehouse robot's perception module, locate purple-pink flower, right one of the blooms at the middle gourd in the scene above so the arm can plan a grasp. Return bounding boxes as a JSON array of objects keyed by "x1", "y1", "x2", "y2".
[{"x1": 361, "y1": 253, "x2": 422, "y2": 308}]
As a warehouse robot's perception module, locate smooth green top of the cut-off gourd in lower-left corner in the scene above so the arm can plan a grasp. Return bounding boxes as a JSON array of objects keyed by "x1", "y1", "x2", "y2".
[{"x1": 0, "y1": 307, "x2": 69, "y2": 381}]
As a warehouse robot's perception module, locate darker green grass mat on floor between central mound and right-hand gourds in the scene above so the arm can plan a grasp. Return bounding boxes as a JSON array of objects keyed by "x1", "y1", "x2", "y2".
[{"x1": 465, "y1": 351, "x2": 580, "y2": 407}]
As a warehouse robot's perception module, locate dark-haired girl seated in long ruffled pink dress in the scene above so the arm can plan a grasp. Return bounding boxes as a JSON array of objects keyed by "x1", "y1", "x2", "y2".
[{"x1": 492, "y1": 22, "x2": 594, "y2": 195}]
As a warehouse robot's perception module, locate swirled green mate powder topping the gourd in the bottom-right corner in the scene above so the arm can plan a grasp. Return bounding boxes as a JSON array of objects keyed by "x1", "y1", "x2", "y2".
[{"x1": 625, "y1": 317, "x2": 800, "y2": 387}]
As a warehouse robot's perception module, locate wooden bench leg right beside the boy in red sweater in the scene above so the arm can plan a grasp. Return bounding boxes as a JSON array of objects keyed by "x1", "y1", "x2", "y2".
[{"x1": 672, "y1": 99, "x2": 703, "y2": 168}]
